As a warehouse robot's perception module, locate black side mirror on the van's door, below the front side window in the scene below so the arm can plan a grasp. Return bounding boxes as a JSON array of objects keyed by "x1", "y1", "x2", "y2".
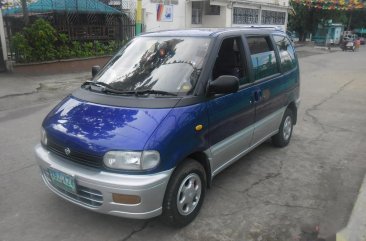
[{"x1": 208, "y1": 75, "x2": 239, "y2": 94}]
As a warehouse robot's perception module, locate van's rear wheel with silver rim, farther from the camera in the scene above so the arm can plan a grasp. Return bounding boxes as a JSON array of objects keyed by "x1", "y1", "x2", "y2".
[{"x1": 272, "y1": 109, "x2": 294, "y2": 147}]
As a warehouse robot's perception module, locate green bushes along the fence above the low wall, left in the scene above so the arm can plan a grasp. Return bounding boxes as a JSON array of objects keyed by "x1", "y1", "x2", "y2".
[{"x1": 11, "y1": 19, "x2": 121, "y2": 63}]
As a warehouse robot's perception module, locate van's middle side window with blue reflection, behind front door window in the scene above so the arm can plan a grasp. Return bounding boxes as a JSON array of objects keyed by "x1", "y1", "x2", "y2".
[{"x1": 247, "y1": 36, "x2": 278, "y2": 80}]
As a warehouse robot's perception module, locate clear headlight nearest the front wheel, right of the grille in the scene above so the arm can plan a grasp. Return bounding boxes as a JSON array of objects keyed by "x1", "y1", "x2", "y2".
[{"x1": 103, "y1": 151, "x2": 160, "y2": 170}]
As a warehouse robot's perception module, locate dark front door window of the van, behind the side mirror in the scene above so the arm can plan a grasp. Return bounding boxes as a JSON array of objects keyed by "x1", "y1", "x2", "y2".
[{"x1": 212, "y1": 37, "x2": 249, "y2": 85}]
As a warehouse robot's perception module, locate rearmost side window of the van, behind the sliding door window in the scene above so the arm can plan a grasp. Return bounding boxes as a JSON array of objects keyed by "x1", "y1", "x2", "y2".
[{"x1": 273, "y1": 35, "x2": 296, "y2": 72}]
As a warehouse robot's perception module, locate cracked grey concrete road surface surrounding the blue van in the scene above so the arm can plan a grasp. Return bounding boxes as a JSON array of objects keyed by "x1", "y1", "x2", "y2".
[{"x1": 0, "y1": 46, "x2": 366, "y2": 241}]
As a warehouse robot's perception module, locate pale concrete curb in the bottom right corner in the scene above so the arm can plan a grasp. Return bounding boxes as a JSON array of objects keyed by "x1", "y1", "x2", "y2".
[{"x1": 336, "y1": 175, "x2": 366, "y2": 241}]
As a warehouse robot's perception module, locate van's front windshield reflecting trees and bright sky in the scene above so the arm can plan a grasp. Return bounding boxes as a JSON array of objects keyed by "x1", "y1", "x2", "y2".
[{"x1": 94, "y1": 37, "x2": 210, "y2": 95}]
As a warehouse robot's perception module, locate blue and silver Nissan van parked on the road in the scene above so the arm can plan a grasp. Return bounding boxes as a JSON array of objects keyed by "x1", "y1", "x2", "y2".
[{"x1": 35, "y1": 27, "x2": 300, "y2": 227}]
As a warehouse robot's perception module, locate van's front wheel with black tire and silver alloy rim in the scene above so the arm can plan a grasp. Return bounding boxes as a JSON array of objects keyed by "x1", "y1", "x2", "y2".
[{"x1": 162, "y1": 159, "x2": 207, "y2": 227}]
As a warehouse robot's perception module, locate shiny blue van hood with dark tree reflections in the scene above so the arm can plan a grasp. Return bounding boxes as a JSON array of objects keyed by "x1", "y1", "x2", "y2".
[{"x1": 43, "y1": 96, "x2": 171, "y2": 155}]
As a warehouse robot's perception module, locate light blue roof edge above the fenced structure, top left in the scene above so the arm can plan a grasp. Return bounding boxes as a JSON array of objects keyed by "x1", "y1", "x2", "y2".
[{"x1": 3, "y1": 0, "x2": 121, "y2": 16}]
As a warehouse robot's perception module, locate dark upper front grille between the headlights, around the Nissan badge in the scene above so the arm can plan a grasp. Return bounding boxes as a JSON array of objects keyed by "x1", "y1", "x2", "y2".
[{"x1": 47, "y1": 138, "x2": 103, "y2": 168}]
